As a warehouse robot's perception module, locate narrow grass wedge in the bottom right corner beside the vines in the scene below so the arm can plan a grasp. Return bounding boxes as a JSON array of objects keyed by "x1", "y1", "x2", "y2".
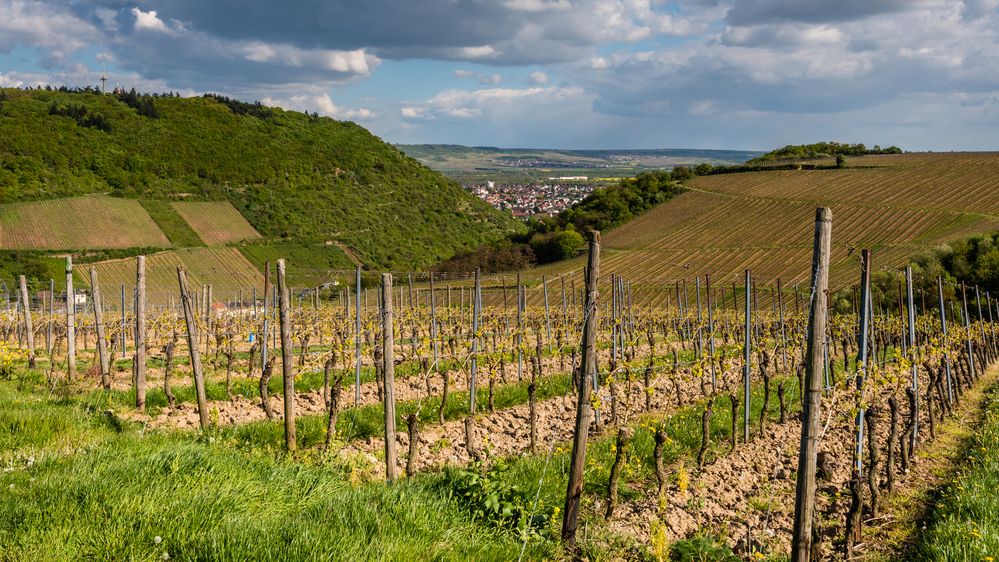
[{"x1": 913, "y1": 378, "x2": 999, "y2": 562}]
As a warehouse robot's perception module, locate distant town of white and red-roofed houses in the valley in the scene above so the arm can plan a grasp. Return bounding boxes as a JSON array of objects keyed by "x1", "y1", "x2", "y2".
[{"x1": 465, "y1": 176, "x2": 596, "y2": 218}]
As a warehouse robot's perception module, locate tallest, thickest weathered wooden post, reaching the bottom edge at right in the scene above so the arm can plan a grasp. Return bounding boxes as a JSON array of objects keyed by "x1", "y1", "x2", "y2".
[{"x1": 781, "y1": 207, "x2": 832, "y2": 562}]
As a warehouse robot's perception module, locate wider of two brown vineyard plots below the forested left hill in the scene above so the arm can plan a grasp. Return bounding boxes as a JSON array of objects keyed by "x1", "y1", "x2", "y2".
[{"x1": 0, "y1": 195, "x2": 171, "y2": 250}]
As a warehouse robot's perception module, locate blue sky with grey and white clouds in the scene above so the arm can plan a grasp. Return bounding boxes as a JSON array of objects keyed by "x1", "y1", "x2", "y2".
[{"x1": 0, "y1": 0, "x2": 999, "y2": 151}]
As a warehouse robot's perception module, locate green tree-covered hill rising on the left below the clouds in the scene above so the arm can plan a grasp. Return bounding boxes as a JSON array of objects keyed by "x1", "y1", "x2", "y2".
[{"x1": 0, "y1": 89, "x2": 522, "y2": 268}]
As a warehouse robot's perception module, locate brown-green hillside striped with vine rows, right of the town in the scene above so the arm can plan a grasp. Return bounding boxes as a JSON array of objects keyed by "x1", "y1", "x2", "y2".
[{"x1": 531, "y1": 153, "x2": 999, "y2": 294}]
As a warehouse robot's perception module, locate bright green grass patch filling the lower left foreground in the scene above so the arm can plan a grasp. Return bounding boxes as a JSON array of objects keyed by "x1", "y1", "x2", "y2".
[{"x1": 0, "y1": 370, "x2": 557, "y2": 561}]
